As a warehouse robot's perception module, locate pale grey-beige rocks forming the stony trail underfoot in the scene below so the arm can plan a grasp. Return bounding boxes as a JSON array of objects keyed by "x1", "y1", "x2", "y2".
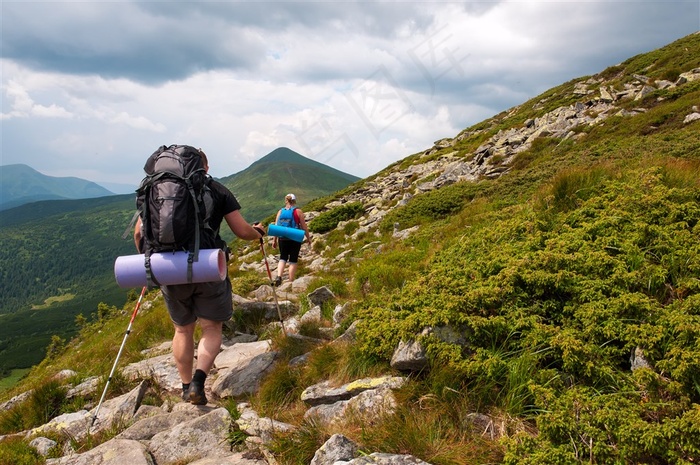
[{"x1": 2, "y1": 275, "x2": 432, "y2": 465}]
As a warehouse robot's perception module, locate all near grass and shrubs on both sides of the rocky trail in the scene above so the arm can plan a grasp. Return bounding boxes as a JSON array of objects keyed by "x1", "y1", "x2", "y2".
[{"x1": 0, "y1": 34, "x2": 700, "y2": 465}]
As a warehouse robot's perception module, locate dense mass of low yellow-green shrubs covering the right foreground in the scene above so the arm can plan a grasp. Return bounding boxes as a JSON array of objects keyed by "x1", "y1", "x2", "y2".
[{"x1": 356, "y1": 163, "x2": 700, "y2": 464}]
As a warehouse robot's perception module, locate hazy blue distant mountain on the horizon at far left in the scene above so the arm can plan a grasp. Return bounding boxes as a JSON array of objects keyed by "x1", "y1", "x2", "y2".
[{"x1": 0, "y1": 164, "x2": 114, "y2": 210}]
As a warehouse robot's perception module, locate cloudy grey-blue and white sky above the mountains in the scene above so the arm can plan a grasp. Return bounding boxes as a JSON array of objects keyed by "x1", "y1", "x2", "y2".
[{"x1": 0, "y1": 0, "x2": 700, "y2": 192}]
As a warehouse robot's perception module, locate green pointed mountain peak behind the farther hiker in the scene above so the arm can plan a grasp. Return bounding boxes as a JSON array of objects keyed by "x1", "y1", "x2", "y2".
[{"x1": 220, "y1": 147, "x2": 359, "y2": 222}]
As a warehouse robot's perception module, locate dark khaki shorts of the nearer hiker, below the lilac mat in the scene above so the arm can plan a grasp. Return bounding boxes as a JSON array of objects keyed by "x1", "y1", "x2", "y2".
[{"x1": 161, "y1": 277, "x2": 233, "y2": 326}]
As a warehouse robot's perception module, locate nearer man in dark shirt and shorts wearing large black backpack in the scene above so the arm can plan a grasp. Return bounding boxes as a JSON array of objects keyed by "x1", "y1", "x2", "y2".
[{"x1": 134, "y1": 145, "x2": 265, "y2": 405}]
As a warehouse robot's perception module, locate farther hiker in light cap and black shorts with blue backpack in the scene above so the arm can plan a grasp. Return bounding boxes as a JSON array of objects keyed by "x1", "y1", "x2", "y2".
[{"x1": 272, "y1": 194, "x2": 311, "y2": 286}]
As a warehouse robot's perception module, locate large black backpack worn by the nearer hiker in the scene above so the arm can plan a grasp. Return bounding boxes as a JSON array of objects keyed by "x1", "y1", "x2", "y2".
[{"x1": 131, "y1": 145, "x2": 217, "y2": 285}]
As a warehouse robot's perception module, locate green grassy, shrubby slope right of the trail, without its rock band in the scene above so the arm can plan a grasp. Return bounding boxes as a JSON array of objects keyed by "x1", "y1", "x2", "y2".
[{"x1": 354, "y1": 31, "x2": 700, "y2": 464}]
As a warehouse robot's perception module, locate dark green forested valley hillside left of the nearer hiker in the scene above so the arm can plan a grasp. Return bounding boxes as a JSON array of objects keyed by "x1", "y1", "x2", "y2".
[{"x1": 0, "y1": 195, "x2": 133, "y2": 375}]
